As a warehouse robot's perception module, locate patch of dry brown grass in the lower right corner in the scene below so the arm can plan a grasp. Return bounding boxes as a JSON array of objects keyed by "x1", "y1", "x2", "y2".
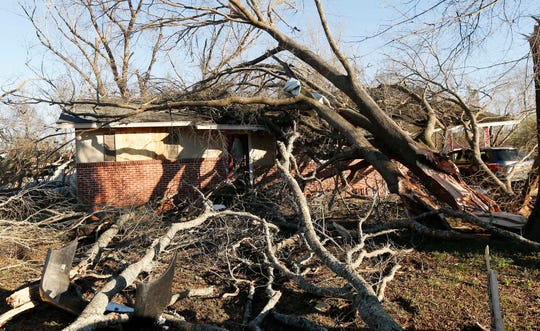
[{"x1": 386, "y1": 240, "x2": 540, "y2": 330}]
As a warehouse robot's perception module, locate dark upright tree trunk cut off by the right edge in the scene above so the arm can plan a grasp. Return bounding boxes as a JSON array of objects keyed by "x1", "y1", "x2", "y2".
[{"x1": 524, "y1": 18, "x2": 540, "y2": 241}]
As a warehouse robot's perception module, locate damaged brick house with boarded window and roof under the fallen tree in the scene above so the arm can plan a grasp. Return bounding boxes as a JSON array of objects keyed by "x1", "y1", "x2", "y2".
[{"x1": 57, "y1": 105, "x2": 276, "y2": 206}]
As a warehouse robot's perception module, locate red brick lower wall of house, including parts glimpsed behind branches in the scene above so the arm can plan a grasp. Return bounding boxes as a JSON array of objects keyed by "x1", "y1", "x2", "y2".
[{"x1": 77, "y1": 158, "x2": 388, "y2": 206}]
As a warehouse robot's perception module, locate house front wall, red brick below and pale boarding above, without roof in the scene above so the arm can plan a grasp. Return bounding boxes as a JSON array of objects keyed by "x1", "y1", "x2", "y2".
[{"x1": 76, "y1": 127, "x2": 275, "y2": 206}]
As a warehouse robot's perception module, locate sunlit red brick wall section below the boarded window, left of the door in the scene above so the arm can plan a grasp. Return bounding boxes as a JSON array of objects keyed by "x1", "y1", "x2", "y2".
[{"x1": 77, "y1": 159, "x2": 225, "y2": 206}]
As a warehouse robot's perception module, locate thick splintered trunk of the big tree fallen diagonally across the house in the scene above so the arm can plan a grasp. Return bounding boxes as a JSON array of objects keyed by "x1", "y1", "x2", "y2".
[{"x1": 230, "y1": 0, "x2": 510, "y2": 226}]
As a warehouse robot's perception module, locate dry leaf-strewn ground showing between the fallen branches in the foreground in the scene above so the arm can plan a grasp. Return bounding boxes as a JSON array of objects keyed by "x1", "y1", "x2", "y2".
[{"x1": 0, "y1": 238, "x2": 540, "y2": 331}]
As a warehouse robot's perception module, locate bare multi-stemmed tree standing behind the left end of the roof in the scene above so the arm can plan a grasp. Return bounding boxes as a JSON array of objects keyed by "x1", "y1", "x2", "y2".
[{"x1": 23, "y1": 1, "x2": 158, "y2": 99}]
